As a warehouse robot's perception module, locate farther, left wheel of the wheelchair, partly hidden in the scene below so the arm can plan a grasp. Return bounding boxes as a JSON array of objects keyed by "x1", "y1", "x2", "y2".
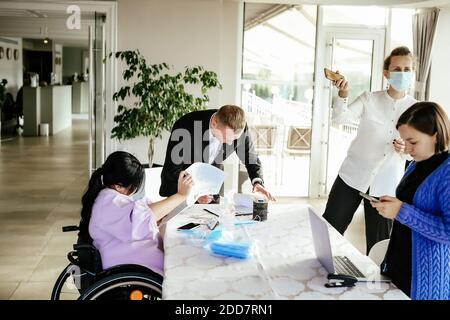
[{"x1": 50, "y1": 263, "x2": 85, "y2": 300}]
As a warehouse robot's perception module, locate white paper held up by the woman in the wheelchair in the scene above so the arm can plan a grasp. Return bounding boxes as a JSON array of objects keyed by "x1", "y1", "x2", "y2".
[{"x1": 186, "y1": 162, "x2": 225, "y2": 206}]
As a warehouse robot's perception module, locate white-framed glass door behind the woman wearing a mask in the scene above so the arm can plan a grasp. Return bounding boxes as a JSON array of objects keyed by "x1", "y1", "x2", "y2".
[{"x1": 321, "y1": 27, "x2": 384, "y2": 195}]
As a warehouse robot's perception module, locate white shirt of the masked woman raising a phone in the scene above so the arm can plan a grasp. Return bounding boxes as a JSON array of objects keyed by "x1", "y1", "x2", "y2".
[{"x1": 333, "y1": 91, "x2": 416, "y2": 197}]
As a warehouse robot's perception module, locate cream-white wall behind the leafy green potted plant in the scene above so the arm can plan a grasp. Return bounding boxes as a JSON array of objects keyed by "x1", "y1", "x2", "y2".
[{"x1": 117, "y1": 0, "x2": 241, "y2": 164}]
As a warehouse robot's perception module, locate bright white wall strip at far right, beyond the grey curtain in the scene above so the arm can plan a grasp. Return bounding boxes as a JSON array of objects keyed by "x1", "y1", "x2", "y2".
[{"x1": 430, "y1": 8, "x2": 450, "y2": 117}]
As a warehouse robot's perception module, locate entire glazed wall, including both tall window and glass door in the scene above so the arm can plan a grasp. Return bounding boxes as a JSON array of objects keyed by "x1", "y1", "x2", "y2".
[{"x1": 240, "y1": 3, "x2": 414, "y2": 196}]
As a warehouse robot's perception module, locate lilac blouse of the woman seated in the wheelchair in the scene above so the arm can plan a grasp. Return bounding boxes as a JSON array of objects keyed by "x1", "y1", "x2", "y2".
[{"x1": 89, "y1": 188, "x2": 164, "y2": 275}]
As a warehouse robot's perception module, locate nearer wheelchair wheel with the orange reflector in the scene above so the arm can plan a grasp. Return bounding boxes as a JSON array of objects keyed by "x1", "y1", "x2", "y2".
[{"x1": 79, "y1": 272, "x2": 162, "y2": 300}]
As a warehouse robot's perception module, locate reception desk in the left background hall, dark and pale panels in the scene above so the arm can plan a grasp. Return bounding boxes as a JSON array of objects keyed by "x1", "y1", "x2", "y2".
[{"x1": 23, "y1": 86, "x2": 72, "y2": 136}]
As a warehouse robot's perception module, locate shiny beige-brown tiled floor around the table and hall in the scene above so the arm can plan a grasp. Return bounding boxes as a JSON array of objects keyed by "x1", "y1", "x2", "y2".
[{"x1": 0, "y1": 119, "x2": 365, "y2": 300}]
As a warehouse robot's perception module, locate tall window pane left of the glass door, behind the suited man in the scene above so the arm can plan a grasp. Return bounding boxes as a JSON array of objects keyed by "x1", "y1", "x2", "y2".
[{"x1": 241, "y1": 4, "x2": 316, "y2": 196}]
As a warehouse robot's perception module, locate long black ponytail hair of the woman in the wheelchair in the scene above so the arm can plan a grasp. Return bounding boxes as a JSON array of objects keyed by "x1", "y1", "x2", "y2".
[{"x1": 78, "y1": 151, "x2": 145, "y2": 243}]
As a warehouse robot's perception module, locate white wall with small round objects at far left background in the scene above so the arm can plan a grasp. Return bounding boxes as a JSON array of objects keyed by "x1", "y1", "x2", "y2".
[{"x1": 0, "y1": 36, "x2": 23, "y2": 96}]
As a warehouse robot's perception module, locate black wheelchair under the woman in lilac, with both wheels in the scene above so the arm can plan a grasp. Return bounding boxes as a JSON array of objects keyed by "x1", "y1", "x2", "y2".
[{"x1": 51, "y1": 226, "x2": 163, "y2": 300}]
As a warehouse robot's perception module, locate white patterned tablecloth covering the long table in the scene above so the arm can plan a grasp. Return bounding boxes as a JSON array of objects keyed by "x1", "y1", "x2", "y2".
[{"x1": 163, "y1": 204, "x2": 408, "y2": 299}]
